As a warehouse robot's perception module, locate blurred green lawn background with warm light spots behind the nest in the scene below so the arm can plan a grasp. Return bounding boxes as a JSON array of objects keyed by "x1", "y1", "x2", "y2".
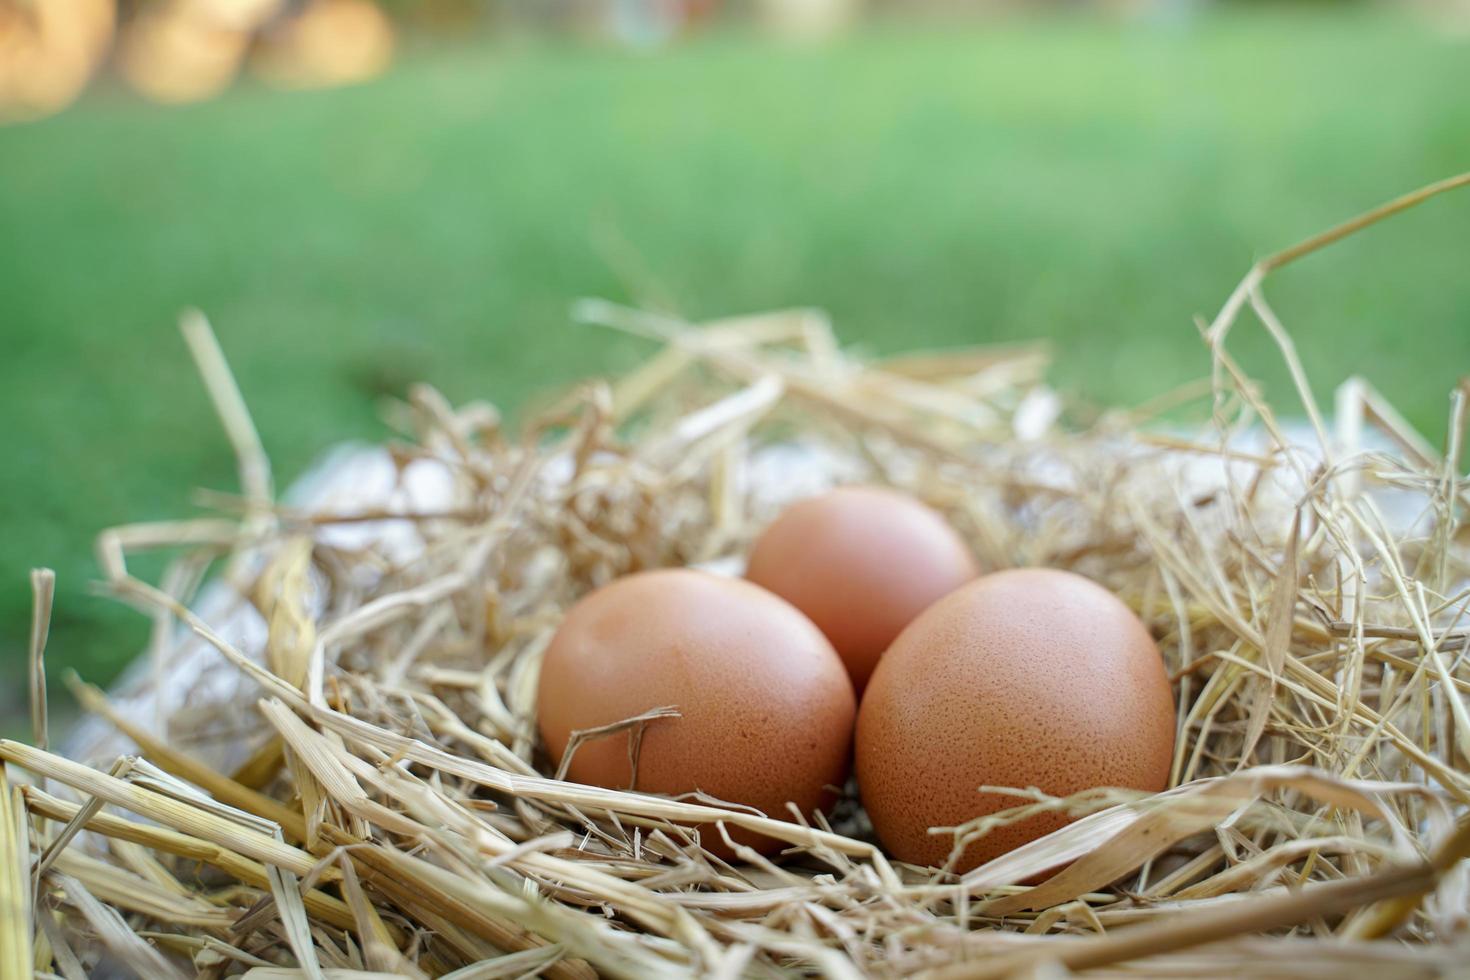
[{"x1": 0, "y1": 0, "x2": 1470, "y2": 727}]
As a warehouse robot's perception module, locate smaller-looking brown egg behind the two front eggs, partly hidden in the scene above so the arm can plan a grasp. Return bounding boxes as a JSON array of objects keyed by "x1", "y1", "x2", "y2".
[{"x1": 745, "y1": 486, "x2": 979, "y2": 692}]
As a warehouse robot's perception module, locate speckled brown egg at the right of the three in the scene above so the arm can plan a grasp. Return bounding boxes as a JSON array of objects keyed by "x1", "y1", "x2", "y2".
[{"x1": 857, "y1": 569, "x2": 1175, "y2": 871}]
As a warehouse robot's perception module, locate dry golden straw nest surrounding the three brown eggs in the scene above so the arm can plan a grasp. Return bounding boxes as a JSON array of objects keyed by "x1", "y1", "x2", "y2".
[{"x1": 0, "y1": 175, "x2": 1470, "y2": 980}]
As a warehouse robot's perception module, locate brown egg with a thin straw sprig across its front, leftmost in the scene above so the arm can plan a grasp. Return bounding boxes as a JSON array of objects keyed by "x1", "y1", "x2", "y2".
[{"x1": 537, "y1": 569, "x2": 857, "y2": 857}]
